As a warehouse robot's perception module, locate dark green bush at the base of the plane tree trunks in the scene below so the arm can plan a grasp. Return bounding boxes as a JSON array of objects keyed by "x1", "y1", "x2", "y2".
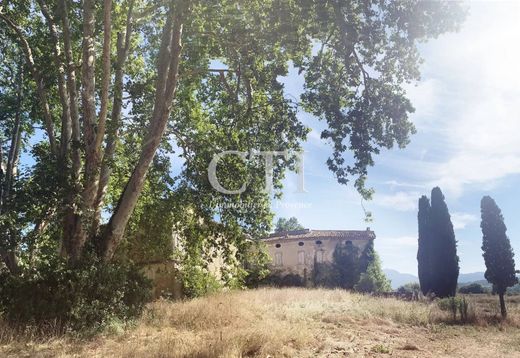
[{"x1": 0, "y1": 259, "x2": 151, "y2": 331}]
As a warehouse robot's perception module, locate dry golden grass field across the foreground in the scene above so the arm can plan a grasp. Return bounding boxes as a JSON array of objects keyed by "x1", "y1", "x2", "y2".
[{"x1": 0, "y1": 288, "x2": 520, "y2": 358}]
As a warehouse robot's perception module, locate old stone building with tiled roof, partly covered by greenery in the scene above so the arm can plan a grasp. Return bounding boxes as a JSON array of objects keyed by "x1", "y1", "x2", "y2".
[{"x1": 262, "y1": 228, "x2": 376, "y2": 277}]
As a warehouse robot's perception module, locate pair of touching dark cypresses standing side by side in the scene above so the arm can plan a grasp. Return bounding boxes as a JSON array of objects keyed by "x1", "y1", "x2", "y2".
[{"x1": 417, "y1": 187, "x2": 459, "y2": 297}]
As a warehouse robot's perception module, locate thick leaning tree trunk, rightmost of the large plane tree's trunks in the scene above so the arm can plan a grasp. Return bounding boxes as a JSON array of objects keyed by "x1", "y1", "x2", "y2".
[{"x1": 101, "y1": 2, "x2": 187, "y2": 261}]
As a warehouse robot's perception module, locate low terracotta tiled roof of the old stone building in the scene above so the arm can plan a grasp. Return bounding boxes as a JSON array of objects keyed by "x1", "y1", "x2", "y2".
[{"x1": 263, "y1": 228, "x2": 376, "y2": 241}]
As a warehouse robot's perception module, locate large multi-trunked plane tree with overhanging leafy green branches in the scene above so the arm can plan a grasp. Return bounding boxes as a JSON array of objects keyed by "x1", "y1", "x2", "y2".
[{"x1": 0, "y1": 0, "x2": 463, "y2": 272}]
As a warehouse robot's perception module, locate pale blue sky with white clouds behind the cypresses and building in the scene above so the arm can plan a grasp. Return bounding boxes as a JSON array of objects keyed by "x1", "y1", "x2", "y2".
[{"x1": 273, "y1": 2, "x2": 520, "y2": 274}]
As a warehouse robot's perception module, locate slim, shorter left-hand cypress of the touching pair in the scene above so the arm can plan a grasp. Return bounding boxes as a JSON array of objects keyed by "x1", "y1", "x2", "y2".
[{"x1": 417, "y1": 195, "x2": 433, "y2": 295}]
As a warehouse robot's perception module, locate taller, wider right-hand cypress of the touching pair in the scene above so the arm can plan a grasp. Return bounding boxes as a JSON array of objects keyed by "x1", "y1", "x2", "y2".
[{"x1": 430, "y1": 187, "x2": 459, "y2": 297}]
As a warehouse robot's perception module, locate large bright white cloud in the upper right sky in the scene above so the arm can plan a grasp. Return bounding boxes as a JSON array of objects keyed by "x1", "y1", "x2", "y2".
[{"x1": 410, "y1": 2, "x2": 520, "y2": 196}]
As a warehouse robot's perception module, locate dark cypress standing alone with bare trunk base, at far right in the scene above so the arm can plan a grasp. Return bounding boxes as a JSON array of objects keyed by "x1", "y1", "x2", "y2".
[{"x1": 480, "y1": 196, "x2": 518, "y2": 318}]
